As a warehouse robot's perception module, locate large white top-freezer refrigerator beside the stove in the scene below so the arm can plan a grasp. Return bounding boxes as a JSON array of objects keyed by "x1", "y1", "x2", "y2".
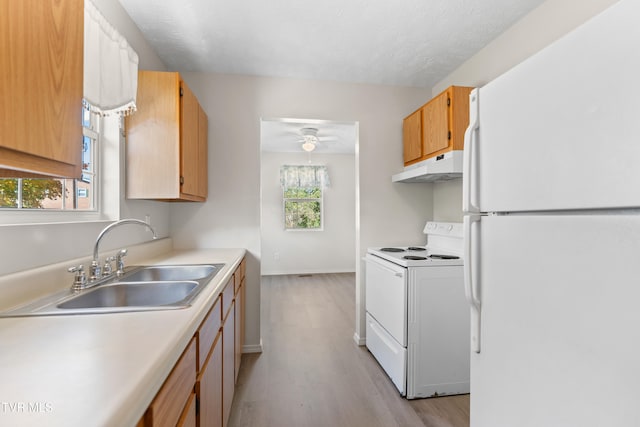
[{"x1": 463, "y1": 0, "x2": 640, "y2": 427}]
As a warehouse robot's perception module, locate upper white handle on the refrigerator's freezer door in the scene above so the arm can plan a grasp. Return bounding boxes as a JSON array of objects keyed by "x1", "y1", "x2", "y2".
[{"x1": 462, "y1": 89, "x2": 480, "y2": 213}]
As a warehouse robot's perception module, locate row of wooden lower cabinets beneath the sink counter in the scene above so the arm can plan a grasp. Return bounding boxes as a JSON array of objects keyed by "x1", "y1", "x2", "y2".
[{"x1": 138, "y1": 259, "x2": 245, "y2": 427}]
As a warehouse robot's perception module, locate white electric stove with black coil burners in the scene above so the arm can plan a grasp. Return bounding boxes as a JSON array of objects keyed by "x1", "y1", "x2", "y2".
[{"x1": 365, "y1": 222, "x2": 470, "y2": 399}]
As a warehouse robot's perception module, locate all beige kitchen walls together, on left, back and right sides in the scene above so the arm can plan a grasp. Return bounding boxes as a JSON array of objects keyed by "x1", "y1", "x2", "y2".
[{"x1": 0, "y1": 0, "x2": 614, "y2": 345}]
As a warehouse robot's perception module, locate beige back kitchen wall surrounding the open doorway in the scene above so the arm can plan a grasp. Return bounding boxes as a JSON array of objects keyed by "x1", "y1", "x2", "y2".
[{"x1": 170, "y1": 73, "x2": 432, "y2": 345}]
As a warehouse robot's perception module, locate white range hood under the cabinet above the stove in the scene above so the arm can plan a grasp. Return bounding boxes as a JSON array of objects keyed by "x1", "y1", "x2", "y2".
[{"x1": 391, "y1": 150, "x2": 462, "y2": 182}]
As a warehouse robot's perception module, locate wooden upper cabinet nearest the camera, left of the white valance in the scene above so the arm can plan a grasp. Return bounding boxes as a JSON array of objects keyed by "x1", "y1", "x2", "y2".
[{"x1": 0, "y1": 0, "x2": 84, "y2": 178}]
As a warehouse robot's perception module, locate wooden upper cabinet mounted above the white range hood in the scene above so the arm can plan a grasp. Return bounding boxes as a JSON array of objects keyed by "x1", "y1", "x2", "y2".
[{"x1": 402, "y1": 86, "x2": 473, "y2": 166}]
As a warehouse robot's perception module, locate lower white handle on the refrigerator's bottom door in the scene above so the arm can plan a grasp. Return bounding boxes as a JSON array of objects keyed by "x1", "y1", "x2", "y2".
[{"x1": 463, "y1": 215, "x2": 482, "y2": 353}]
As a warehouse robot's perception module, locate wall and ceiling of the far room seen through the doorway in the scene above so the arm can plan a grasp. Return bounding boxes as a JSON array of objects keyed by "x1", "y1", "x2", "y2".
[{"x1": 260, "y1": 118, "x2": 359, "y2": 276}]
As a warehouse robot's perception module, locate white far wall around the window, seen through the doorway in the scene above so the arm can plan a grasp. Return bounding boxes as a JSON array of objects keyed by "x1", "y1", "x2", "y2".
[{"x1": 260, "y1": 152, "x2": 356, "y2": 275}]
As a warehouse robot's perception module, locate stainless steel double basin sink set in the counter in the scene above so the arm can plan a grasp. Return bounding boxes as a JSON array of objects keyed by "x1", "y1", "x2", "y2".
[{"x1": 0, "y1": 264, "x2": 224, "y2": 317}]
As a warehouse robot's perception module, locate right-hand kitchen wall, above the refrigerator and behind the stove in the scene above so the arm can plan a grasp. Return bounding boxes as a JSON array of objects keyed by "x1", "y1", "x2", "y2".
[{"x1": 432, "y1": 0, "x2": 617, "y2": 222}]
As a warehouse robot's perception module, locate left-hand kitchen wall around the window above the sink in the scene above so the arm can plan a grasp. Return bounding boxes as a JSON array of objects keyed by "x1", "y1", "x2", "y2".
[{"x1": 0, "y1": 0, "x2": 169, "y2": 275}]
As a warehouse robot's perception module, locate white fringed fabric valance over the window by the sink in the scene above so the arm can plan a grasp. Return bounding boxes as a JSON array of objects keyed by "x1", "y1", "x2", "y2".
[{"x1": 83, "y1": 0, "x2": 138, "y2": 115}]
